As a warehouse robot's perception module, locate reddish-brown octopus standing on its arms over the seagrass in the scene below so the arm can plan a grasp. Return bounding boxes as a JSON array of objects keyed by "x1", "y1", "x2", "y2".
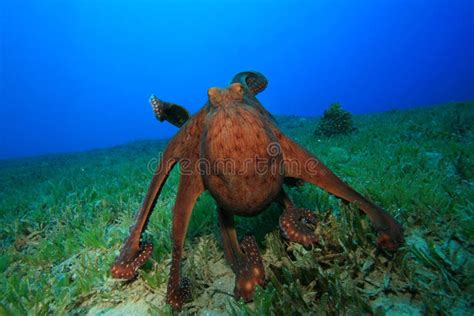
[{"x1": 111, "y1": 71, "x2": 403, "y2": 309}]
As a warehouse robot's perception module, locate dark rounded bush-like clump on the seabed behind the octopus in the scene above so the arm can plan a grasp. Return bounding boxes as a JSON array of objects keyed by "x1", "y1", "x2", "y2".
[{"x1": 314, "y1": 102, "x2": 357, "y2": 136}]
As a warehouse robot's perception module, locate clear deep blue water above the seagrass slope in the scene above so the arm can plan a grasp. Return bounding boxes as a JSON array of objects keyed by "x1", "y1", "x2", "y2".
[{"x1": 0, "y1": 0, "x2": 474, "y2": 159}]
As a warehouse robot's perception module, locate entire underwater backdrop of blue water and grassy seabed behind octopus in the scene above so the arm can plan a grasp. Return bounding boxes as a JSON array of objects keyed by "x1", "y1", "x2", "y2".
[{"x1": 0, "y1": 0, "x2": 474, "y2": 315}]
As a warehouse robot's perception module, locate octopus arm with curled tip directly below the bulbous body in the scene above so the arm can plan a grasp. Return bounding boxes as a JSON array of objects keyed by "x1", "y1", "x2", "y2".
[{"x1": 218, "y1": 208, "x2": 265, "y2": 301}]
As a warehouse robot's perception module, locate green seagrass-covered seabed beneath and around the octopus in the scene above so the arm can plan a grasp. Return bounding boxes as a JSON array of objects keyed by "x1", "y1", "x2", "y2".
[{"x1": 0, "y1": 102, "x2": 474, "y2": 315}]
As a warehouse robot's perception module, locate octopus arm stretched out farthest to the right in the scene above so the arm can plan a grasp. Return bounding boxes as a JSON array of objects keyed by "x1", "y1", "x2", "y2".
[{"x1": 273, "y1": 128, "x2": 403, "y2": 250}]
